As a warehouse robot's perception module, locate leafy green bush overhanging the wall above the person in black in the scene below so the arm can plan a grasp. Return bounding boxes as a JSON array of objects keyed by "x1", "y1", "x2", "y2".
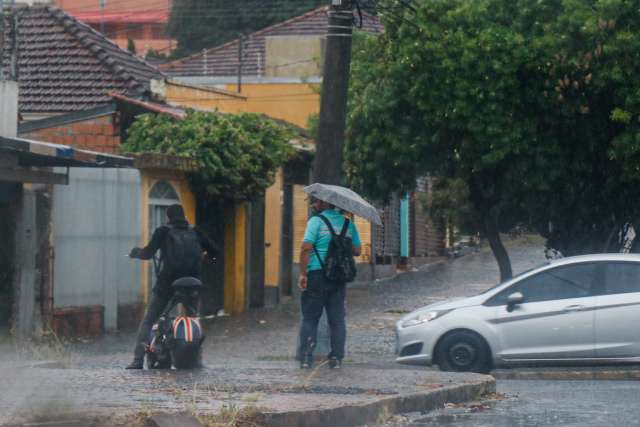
[{"x1": 123, "y1": 111, "x2": 295, "y2": 200}]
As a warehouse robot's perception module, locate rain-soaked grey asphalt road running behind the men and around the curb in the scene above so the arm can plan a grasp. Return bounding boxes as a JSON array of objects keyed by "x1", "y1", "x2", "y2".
[{"x1": 5, "y1": 238, "x2": 640, "y2": 426}]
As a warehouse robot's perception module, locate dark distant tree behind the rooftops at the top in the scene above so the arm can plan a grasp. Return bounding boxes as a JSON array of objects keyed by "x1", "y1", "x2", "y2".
[{"x1": 168, "y1": 0, "x2": 327, "y2": 57}]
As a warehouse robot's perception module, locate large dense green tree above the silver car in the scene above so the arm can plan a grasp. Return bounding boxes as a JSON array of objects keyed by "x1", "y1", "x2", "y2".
[{"x1": 346, "y1": 0, "x2": 640, "y2": 279}]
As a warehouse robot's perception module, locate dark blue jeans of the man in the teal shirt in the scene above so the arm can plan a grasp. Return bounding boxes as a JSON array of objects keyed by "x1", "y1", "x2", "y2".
[{"x1": 300, "y1": 270, "x2": 347, "y2": 360}]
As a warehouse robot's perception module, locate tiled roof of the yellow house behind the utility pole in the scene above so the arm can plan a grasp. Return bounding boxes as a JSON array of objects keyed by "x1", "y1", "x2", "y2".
[{"x1": 160, "y1": 6, "x2": 383, "y2": 77}]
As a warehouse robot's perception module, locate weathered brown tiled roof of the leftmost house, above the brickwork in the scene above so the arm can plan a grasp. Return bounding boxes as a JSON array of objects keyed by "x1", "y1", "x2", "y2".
[{"x1": 0, "y1": 5, "x2": 162, "y2": 113}]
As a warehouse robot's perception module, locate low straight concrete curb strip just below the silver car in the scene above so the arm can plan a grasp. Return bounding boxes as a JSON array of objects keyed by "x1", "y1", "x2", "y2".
[{"x1": 491, "y1": 368, "x2": 640, "y2": 381}]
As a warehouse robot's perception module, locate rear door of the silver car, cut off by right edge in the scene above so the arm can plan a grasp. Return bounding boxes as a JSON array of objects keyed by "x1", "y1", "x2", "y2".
[{"x1": 595, "y1": 262, "x2": 640, "y2": 358}]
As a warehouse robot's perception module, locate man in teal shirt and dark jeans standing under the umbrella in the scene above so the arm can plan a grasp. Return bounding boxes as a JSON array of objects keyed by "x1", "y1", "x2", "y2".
[{"x1": 298, "y1": 198, "x2": 362, "y2": 368}]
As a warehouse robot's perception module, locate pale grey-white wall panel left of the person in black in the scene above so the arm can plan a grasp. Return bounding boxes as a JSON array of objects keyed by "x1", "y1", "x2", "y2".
[{"x1": 53, "y1": 168, "x2": 142, "y2": 330}]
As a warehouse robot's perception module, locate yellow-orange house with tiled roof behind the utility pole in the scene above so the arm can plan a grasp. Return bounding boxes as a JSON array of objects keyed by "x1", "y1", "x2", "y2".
[{"x1": 155, "y1": 7, "x2": 383, "y2": 302}]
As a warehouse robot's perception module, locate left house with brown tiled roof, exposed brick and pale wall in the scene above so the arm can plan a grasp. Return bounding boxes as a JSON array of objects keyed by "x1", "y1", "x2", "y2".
[{"x1": 0, "y1": 5, "x2": 196, "y2": 335}]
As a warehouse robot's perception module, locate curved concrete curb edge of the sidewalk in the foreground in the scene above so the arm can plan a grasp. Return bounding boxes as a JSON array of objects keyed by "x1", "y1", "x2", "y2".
[{"x1": 264, "y1": 376, "x2": 496, "y2": 427}]
